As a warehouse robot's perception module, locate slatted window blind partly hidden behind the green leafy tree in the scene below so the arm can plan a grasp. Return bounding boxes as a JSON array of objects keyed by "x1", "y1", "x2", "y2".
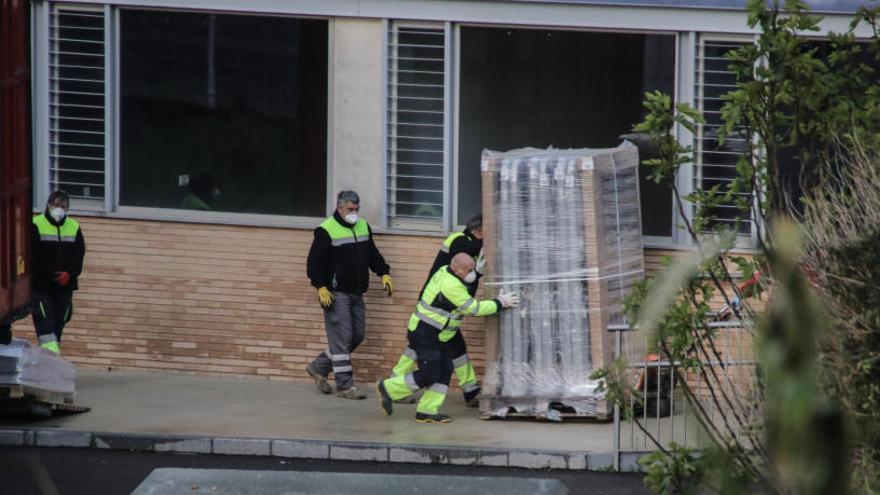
[{"x1": 694, "y1": 39, "x2": 752, "y2": 235}]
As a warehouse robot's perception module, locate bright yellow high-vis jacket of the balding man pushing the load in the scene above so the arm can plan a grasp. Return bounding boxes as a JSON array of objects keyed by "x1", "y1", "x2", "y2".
[{"x1": 407, "y1": 266, "x2": 501, "y2": 342}]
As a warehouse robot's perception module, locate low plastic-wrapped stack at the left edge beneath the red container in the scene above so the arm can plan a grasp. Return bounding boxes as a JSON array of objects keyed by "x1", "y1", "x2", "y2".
[{"x1": 0, "y1": 339, "x2": 76, "y2": 396}]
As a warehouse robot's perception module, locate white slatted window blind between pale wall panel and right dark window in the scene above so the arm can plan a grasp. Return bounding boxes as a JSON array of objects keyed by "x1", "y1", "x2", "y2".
[{"x1": 386, "y1": 23, "x2": 447, "y2": 230}]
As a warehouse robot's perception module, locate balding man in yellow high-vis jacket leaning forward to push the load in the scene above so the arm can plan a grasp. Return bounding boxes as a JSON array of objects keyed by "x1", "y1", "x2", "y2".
[{"x1": 376, "y1": 253, "x2": 519, "y2": 423}]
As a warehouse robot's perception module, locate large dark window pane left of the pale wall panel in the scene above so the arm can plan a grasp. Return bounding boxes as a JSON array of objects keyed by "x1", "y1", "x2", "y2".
[{"x1": 120, "y1": 10, "x2": 328, "y2": 216}]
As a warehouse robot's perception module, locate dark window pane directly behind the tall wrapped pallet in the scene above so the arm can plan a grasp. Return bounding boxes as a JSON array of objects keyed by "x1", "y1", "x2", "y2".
[{"x1": 458, "y1": 27, "x2": 675, "y2": 236}]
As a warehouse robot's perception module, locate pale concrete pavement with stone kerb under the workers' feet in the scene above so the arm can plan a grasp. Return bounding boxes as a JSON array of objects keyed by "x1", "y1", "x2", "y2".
[{"x1": 0, "y1": 370, "x2": 624, "y2": 469}]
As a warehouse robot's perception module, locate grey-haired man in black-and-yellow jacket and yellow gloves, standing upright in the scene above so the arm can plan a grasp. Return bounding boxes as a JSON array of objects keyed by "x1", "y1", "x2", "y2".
[{"x1": 306, "y1": 191, "x2": 394, "y2": 399}]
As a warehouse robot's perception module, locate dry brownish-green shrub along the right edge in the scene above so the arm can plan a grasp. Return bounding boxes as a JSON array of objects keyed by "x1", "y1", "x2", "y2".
[{"x1": 804, "y1": 149, "x2": 880, "y2": 493}]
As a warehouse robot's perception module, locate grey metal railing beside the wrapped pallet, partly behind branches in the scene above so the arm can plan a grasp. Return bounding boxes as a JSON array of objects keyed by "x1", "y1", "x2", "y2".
[{"x1": 608, "y1": 316, "x2": 759, "y2": 470}]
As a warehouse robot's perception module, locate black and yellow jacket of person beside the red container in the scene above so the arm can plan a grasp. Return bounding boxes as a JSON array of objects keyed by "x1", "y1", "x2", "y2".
[{"x1": 31, "y1": 212, "x2": 86, "y2": 292}]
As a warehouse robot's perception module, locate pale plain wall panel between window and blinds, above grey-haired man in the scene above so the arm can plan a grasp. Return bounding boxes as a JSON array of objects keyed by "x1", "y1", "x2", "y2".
[{"x1": 330, "y1": 18, "x2": 385, "y2": 219}]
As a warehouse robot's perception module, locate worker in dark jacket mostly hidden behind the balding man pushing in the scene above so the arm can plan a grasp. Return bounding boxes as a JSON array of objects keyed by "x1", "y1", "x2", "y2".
[{"x1": 391, "y1": 213, "x2": 485, "y2": 407}]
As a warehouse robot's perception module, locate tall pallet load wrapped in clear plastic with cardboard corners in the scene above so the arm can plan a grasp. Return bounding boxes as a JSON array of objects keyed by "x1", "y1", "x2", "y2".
[{"x1": 480, "y1": 143, "x2": 644, "y2": 419}]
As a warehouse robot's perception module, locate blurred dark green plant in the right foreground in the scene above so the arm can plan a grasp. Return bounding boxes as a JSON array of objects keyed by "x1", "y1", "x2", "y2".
[{"x1": 758, "y1": 222, "x2": 850, "y2": 495}]
